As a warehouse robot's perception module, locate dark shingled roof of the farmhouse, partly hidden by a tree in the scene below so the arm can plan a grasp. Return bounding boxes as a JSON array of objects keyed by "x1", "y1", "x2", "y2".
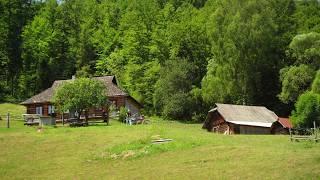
[{"x1": 21, "y1": 76, "x2": 128, "y2": 104}]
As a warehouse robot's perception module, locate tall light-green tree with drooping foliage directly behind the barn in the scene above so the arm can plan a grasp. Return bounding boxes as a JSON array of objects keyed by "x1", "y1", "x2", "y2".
[{"x1": 202, "y1": 1, "x2": 293, "y2": 107}]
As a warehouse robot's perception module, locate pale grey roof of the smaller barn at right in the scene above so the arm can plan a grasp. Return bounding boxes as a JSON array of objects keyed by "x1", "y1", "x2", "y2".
[{"x1": 209, "y1": 103, "x2": 278, "y2": 127}]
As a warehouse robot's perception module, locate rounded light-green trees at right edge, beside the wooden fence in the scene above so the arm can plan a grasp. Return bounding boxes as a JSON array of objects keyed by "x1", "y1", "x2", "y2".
[{"x1": 279, "y1": 32, "x2": 320, "y2": 121}]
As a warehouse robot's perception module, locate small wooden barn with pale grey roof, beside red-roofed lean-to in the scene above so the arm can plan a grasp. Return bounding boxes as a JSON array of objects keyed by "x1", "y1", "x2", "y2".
[{"x1": 203, "y1": 103, "x2": 278, "y2": 134}]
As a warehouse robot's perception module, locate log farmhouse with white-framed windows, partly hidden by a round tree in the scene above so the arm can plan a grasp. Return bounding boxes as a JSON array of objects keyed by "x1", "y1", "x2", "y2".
[{"x1": 21, "y1": 76, "x2": 142, "y2": 118}]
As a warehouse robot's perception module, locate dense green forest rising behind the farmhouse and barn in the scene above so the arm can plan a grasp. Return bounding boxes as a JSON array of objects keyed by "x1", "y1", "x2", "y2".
[{"x1": 0, "y1": 0, "x2": 320, "y2": 126}]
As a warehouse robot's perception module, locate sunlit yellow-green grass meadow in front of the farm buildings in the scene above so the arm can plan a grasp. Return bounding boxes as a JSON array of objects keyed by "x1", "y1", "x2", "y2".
[{"x1": 0, "y1": 104, "x2": 320, "y2": 179}]
